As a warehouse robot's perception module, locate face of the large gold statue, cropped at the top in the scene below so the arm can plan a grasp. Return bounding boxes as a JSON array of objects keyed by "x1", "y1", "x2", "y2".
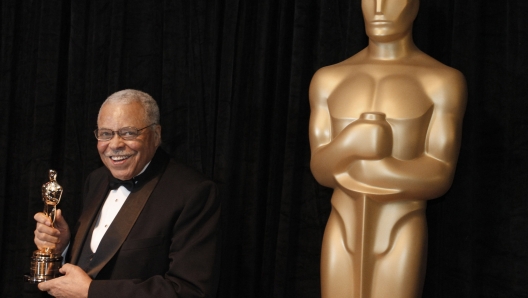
[{"x1": 361, "y1": 0, "x2": 419, "y2": 42}]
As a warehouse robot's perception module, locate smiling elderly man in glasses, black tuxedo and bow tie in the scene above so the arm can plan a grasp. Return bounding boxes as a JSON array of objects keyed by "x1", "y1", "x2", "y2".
[{"x1": 35, "y1": 90, "x2": 220, "y2": 297}]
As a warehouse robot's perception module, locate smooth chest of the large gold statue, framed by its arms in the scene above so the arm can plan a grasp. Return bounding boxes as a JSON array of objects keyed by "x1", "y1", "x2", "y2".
[{"x1": 327, "y1": 65, "x2": 433, "y2": 160}]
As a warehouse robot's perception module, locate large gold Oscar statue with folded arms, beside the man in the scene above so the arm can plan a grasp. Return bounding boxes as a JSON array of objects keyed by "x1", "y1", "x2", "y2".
[{"x1": 310, "y1": 0, "x2": 466, "y2": 298}]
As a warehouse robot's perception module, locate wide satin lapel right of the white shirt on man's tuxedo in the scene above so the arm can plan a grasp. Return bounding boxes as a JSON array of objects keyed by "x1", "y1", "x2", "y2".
[{"x1": 84, "y1": 174, "x2": 161, "y2": 277}]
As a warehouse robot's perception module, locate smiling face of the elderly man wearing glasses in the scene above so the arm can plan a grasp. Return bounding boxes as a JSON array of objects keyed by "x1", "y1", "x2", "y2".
[{"x1": 97, "y1": 102, "x2": 161, "y2": 180}]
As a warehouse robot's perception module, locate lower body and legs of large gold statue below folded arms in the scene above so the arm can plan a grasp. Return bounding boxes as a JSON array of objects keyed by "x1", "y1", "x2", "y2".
[{"x1": 321, "y1": 189, "x2": 427, "y2": 298}]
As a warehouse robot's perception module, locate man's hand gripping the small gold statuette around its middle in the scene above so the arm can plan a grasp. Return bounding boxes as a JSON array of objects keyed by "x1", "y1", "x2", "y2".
[{"x1": 34, "y1": 209, "x2": 70, "y2": 254}]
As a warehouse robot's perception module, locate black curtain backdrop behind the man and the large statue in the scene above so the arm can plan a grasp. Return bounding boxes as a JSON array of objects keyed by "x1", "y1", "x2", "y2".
[{"x1": 0, "y1": 0, "x2": 528, "y2": 298}]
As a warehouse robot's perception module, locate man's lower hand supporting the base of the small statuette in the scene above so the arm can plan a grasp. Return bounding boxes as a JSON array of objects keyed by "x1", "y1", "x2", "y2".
[{"x1": 38, "y1": 264, "x2": 92, "y2": 298}]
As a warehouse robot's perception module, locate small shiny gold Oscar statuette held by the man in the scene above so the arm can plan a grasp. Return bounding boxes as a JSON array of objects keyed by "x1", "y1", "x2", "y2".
[{"x1": 25, "y1": 170, "x2": 62, "y2": 283}]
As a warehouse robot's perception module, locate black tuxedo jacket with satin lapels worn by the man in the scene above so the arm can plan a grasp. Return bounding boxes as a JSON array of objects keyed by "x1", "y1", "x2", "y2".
[{"x1": 69, "y1": 149, "x2": 220, "y2": 298}]
